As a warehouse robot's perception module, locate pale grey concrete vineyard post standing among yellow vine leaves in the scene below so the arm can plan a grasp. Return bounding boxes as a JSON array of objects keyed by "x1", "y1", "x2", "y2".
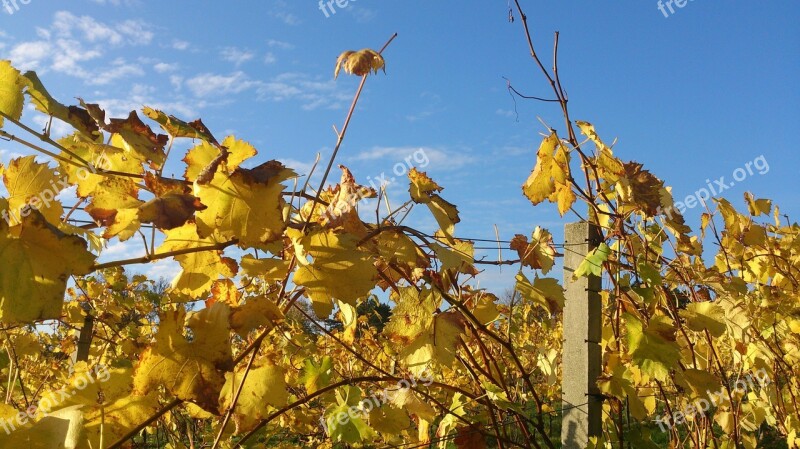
[{"x1": 561, "y1": 222, "x2": 602, "y2": 449}]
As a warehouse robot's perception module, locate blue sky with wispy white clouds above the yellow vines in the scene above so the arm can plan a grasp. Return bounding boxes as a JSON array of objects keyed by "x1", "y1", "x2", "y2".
[{"x1": 0, "y1": 0, "x2": 800, "y2": 290}]
